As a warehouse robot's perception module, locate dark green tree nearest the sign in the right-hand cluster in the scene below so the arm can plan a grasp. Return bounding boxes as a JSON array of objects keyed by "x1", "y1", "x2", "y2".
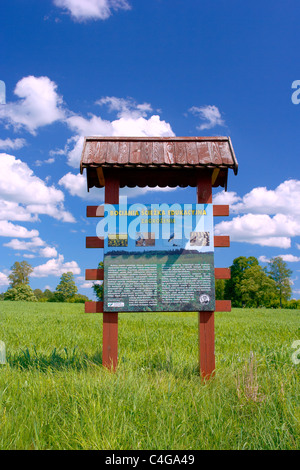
[{"x1": 224, "y1": 256, "x2": 259, "y2": 307}]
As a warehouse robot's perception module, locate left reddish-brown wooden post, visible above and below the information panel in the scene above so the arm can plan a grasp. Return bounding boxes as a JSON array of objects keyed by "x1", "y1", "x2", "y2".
[{"x1": 102, "y1": 174, "x2": 120, "y2": 371}]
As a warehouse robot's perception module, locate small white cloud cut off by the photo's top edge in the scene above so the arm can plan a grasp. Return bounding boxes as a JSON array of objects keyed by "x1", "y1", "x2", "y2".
[{"x1": 54, "y1": 0, "x2": 130, "y2": 21}]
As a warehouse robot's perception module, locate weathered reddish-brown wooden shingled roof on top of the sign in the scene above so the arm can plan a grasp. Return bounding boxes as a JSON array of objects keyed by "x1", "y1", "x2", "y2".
[{"x1": 80, "y1": 137, "x2": 238, "y2": 189}]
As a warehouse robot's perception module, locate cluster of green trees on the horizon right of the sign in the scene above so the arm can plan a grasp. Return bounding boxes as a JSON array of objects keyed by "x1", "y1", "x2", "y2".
[{"x1": 216, "y1": 256, "x2": 300, "y2": 309}]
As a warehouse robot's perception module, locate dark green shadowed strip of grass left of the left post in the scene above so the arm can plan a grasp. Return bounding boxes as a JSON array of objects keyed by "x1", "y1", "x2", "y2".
[{"x1": 7, "y1": 347, "x2": 102, "y2": 372}]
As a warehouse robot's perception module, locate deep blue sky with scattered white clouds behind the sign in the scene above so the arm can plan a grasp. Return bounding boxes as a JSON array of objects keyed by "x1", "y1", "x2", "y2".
[{"x1": 0, "y1": 0, "x2": 300, "y2": 298}]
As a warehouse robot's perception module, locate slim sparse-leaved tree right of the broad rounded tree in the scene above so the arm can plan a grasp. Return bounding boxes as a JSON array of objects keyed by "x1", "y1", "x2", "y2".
[{"x1": 268, "y1": 256, "x2": 292, "y2": 308}]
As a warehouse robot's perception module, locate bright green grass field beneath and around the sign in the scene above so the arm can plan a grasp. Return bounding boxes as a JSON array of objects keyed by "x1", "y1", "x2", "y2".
[{"x1": 0, "y1": 302, "x2": 300, "y2": 450}]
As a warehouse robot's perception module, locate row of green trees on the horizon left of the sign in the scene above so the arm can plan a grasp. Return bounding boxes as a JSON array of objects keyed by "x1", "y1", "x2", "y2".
[{"x1": 0, "y1": 261, "x2": 89, "y2": 303}]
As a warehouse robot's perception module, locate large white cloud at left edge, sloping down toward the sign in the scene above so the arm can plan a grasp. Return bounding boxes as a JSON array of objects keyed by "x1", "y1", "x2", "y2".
[{"x1": 0, "y1": 153, "x2": 75, "y2": 222}]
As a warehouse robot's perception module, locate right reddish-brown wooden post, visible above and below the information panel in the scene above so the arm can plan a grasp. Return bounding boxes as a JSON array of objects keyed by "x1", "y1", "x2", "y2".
[{"x1": 197, "y1": 171, "x2": 215, "y2": 379}]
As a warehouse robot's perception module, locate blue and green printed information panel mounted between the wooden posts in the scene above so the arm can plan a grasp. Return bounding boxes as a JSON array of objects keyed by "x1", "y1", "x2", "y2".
[{"x1": 103, "y1": 204, "x2": 215, "y2": 312}]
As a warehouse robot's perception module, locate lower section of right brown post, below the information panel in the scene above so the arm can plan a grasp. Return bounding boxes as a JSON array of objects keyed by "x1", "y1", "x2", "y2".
[{"x1": 198, "y1": 312, "x2": 215, "y2": 380}]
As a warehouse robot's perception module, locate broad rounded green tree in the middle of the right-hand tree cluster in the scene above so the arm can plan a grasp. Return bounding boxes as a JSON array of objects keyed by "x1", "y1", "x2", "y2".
[{"x1": 238, "y1": 265, "x2": 276, "y2": 308}]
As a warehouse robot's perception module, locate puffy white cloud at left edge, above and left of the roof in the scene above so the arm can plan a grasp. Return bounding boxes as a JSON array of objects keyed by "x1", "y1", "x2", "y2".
[{"x1": 0, "y1": 76, "x2": 65, "y2": 134}]
